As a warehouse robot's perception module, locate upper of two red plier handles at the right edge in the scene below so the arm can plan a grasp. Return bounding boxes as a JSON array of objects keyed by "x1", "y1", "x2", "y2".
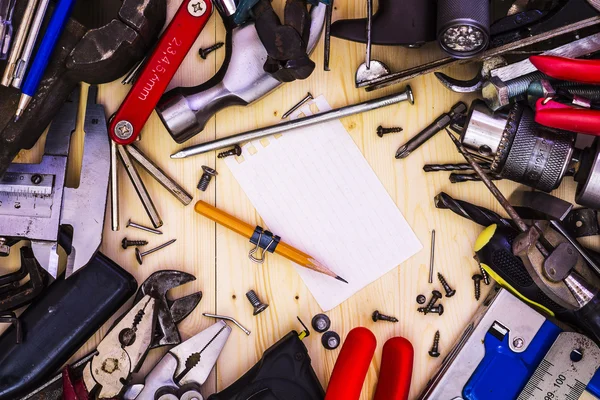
[{"x1": 529, "y1": 56, "x2": 600, "y2": 83}]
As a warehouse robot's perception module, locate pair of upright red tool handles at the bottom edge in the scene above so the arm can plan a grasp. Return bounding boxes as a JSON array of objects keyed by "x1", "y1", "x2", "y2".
[{"x1": 325, "y1": 327, "x2": 414, "y2": 400}]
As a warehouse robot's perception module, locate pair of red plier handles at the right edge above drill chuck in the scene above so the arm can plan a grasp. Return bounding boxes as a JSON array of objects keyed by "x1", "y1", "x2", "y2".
[{"x1": 529, "y1": 56, "x2": 600, "y2": 136}]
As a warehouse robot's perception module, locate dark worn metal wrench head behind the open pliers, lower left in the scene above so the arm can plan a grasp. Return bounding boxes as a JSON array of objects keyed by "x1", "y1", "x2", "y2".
[{"x1": 134, "y1": 271, "x2": 202, "y2": 348}]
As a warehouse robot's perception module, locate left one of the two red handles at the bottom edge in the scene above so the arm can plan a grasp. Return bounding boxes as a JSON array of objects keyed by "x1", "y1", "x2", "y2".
[{"x1": 325, "y1": 327, "x2": 377, "y2": 400}]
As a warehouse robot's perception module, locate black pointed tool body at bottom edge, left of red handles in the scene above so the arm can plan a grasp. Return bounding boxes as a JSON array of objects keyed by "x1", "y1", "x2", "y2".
[{"x1": 208, "y1": 331, "x2": 325, "y2": 400}]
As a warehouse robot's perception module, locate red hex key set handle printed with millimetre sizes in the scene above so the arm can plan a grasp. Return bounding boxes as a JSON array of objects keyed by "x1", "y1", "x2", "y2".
[{"x1": 108, "y1": 0, "x2": 213, "y2": 145}]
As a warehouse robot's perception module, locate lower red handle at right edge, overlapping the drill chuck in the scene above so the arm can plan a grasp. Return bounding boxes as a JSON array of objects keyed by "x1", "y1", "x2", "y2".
[{"x1": 535, "y1": 99, "x2": 600, "y2": 136}]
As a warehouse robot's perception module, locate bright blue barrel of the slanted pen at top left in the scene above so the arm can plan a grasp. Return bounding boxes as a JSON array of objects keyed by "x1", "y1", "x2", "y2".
[{"x1": 22, "y1": 0, "x2": 75, "y2": 97}]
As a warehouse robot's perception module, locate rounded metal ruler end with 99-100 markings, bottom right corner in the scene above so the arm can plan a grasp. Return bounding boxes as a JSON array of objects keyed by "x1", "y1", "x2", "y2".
[{"x1": 517, "y1": 332, "x2": 600, "y2": 400}]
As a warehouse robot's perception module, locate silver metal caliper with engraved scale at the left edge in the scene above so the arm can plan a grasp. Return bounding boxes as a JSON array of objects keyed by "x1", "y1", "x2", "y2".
[{"x1": 0, "y1": 86, "x2": 110, "y2": 278}]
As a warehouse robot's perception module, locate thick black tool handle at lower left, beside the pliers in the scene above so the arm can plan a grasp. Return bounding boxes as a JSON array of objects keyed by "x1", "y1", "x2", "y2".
[{"x1": 0, "y1": 253, "x2": 137, "y2": 400}]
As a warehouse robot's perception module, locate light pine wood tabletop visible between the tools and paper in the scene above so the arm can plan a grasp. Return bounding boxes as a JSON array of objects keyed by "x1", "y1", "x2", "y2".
[{"x1": 3, "y1": 0, "x2": 596, "y2": 400}]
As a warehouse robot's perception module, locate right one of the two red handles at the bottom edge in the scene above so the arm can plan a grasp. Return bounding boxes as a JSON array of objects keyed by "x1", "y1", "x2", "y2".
[{"x1": 373, "y1": 337, "x2": 415, "y2": 400}]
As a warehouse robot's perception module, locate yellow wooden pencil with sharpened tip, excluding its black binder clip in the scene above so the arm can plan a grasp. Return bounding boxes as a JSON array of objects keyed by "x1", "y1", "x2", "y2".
[{"x1": 194, "y1": 201, "x2": 348, "y2": 283}]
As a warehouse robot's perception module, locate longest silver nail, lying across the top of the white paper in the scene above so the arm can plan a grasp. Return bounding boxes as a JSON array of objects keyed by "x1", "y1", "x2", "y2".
[{"x1": 171, "y1": 86, "x2": 415, "y2": 158}]
